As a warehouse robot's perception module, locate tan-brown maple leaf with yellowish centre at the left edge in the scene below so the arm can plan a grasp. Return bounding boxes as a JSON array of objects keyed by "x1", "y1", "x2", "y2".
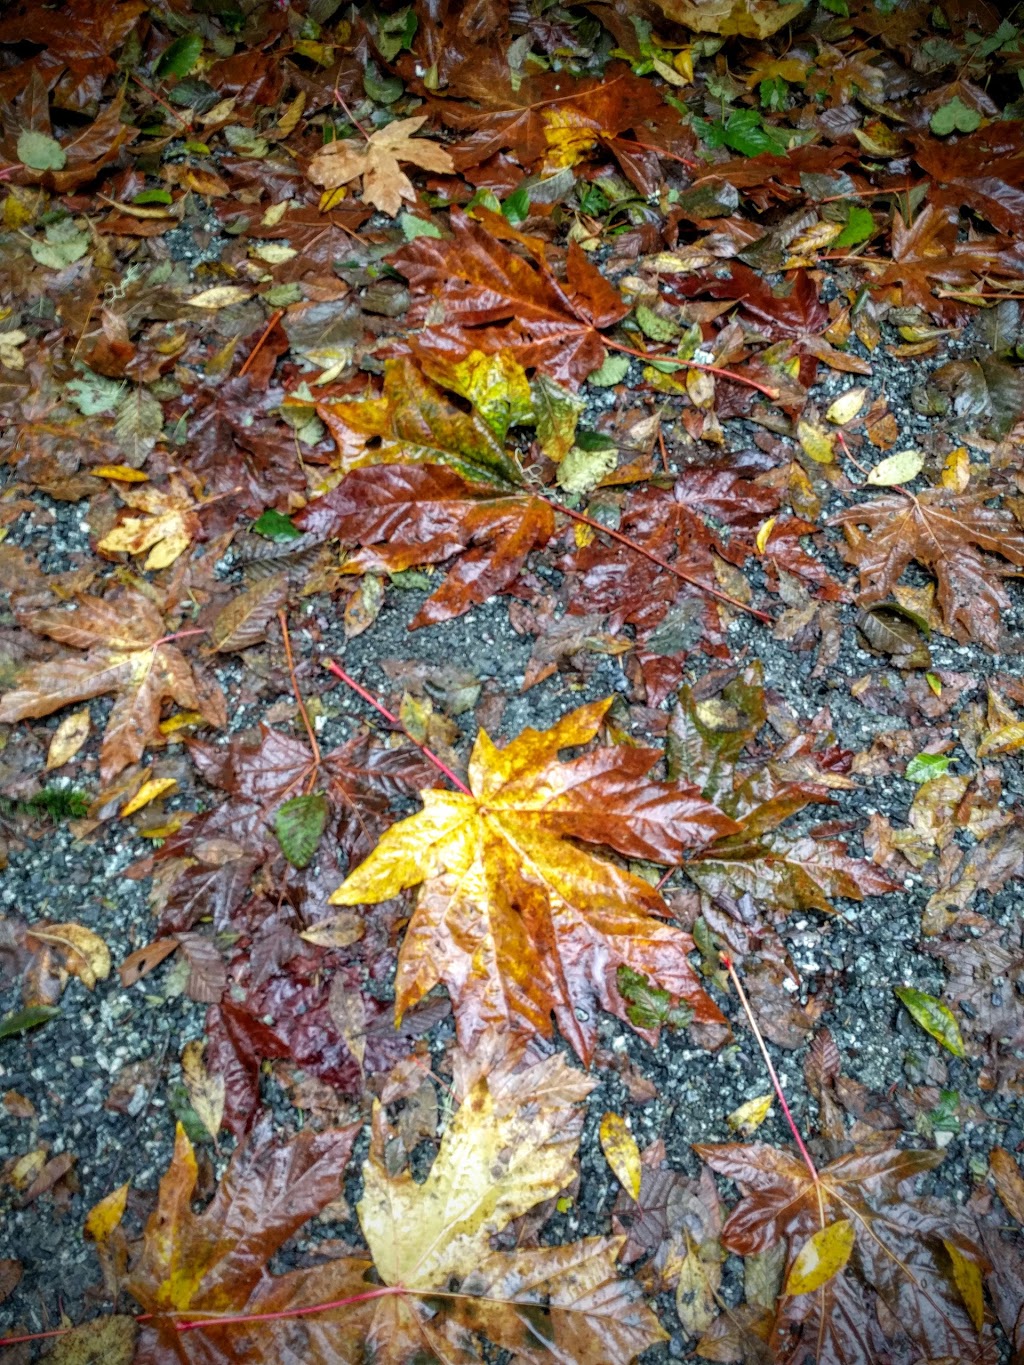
[{"x1": 0, "y1": 592, "x2": 227, "y2": 781}]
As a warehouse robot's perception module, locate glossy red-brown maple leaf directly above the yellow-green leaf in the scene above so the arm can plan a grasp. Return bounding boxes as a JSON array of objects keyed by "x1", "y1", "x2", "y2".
[{"x1": 390, "y1": 210, "x2": 629, "y2": 384}]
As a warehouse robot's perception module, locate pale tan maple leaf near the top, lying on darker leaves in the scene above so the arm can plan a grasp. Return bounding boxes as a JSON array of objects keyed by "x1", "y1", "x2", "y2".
[{"x1": 307, "y1": 113, "x2": 455, "y2": 218}]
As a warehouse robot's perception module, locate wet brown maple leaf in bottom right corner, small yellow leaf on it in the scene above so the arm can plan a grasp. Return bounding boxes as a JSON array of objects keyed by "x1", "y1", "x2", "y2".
[{"x1": 695, "y1": 1134, "x2": 995, "y2": 1365}]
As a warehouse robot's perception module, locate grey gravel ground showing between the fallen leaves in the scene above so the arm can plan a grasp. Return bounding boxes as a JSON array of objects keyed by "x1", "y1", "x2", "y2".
[{"x1": 0, "y1": 290, "x2": 1024, "y2": 1361}]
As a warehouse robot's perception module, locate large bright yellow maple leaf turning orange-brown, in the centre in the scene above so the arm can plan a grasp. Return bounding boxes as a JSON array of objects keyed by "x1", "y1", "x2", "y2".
[{"x1": 330, "y1": 699, "x2": 737, "y2": 1061}]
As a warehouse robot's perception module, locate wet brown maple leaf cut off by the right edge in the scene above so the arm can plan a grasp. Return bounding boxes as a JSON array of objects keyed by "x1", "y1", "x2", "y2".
[{"x1": 830, "y1": 489, "x2": 1024, "y2": 650}]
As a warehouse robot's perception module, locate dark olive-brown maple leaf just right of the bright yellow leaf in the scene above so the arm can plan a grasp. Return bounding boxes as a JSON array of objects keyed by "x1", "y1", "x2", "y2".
[{"x1": 668, "y1": 666, "x2": 896, "y2": 913}]
